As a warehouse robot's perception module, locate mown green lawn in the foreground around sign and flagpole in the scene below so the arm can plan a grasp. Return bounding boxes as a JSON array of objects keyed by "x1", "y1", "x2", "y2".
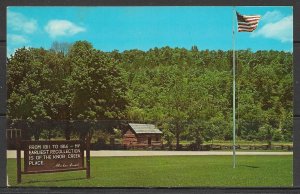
[{"x1": 7, "y1": 156, "x2": 293, "y2": 187}]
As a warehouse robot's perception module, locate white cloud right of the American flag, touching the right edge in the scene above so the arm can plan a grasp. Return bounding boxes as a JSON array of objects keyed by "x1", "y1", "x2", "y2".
[{"x1": 251, "y1": 15, "x2": 293, "y2": 42}]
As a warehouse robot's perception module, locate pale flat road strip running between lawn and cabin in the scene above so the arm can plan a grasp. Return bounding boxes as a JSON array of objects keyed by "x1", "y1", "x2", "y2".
[{"x1": 7, "y1": 150, "x2": 293, "y2": 158}]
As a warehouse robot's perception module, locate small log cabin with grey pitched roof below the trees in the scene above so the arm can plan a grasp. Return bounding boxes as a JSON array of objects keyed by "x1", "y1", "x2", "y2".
[{"x1": 122, "y1": 123, "x2": 162, "y2": 148}]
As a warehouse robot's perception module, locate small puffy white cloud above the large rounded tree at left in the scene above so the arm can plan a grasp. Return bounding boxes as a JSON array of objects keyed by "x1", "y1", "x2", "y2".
[{"x1": 44, "y1": 20, "x2": 85, "y2": 38}]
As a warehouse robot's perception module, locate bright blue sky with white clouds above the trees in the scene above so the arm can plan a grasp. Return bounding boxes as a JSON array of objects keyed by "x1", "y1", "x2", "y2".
[{"x1": 7, "y1": 6, "x2": 293, "y2": 55}]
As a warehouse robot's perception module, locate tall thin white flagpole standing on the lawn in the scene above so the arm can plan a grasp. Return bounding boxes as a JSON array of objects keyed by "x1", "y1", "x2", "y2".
[{"x1": 232, "y1": 6, "x2": 236, "y2": 168}]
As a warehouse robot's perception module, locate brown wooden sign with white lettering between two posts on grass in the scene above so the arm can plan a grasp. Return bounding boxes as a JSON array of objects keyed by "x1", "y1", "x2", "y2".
[{"x1": 17, "y1": 139, "x2": 90, "y2": 183}]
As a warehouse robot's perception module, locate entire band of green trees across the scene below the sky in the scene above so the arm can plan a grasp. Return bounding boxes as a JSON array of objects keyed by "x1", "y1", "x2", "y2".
[{"x1": 7, "y1": 41, "x2": 293, "y2": 148}]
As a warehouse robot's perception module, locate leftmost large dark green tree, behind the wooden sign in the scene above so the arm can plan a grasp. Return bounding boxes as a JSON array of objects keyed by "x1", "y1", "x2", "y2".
[{"x1": 7, "y1": 48, "x2": 65, "y2": 139}]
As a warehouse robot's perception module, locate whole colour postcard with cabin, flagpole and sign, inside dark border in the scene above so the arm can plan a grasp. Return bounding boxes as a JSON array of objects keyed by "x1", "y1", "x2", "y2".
[{"x1": 6, "y1": 6, "x2": 293, "y2": 187}]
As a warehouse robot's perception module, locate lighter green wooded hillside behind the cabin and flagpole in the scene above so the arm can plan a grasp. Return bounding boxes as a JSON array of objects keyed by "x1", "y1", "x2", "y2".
[{"x1": 118, "y1": 47, "x2": 292, "y2": 144}]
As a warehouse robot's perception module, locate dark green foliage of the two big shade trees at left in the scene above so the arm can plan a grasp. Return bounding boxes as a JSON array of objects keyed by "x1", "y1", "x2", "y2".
[{"x1": 7, "y1": 41, "x2": 127, "y2": 139}]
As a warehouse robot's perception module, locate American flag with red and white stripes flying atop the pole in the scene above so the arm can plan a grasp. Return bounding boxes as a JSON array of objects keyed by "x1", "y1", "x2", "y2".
[{"x1": 236, "y1": 12, "x2": 260, "y2": 32}]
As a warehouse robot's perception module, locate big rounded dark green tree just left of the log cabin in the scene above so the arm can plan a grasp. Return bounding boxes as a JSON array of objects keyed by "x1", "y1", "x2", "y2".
[{"x1": 66, "y1": 41, "x2": 127, "y2": 138}]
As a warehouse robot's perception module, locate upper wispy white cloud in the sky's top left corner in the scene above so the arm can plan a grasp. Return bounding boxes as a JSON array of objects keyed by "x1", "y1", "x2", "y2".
[{"x1": 7, "y1": 11, "x2": 38, "y2": 34}]
